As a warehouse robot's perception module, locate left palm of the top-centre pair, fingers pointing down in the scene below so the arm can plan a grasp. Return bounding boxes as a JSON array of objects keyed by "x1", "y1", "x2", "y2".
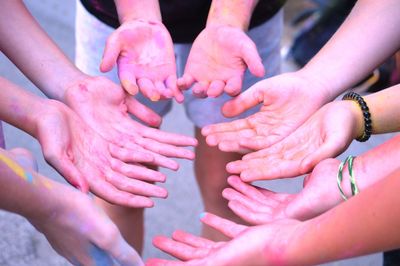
[{"x1": 100, "y1": 20, "x2": 184, "y2": 102}]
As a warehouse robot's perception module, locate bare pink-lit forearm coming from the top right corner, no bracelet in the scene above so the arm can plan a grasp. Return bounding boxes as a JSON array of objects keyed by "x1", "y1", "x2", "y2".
[{"x1": 301, "y1": 0, "x2": 400, "y2": 99}]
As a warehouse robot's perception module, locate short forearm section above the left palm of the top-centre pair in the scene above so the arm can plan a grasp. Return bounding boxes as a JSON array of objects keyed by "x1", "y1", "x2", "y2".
[{"x1": 114, "y1": 0, "x2": 161, "y2": 24}]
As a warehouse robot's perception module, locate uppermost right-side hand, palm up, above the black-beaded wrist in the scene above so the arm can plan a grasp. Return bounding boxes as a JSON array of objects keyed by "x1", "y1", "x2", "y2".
[{"x1": 202, "y1": 72, "x2": 333, "y2": 153}]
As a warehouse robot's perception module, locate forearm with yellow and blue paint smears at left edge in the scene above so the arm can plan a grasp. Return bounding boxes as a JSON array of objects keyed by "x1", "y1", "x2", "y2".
[{"x1": 0, "y1": 149, "x2": 53, "y2": 218}]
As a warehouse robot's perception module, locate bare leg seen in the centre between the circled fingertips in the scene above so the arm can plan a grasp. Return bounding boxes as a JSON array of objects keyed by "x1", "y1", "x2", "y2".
[{"x1": 194, "y1": 127, "x2": 243, "y2": 241}]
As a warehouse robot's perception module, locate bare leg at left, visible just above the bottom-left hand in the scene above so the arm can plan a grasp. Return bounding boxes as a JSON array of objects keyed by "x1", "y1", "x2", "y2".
[{"x1": 96, "y1": 198, "x2": 144, "y2": 254}]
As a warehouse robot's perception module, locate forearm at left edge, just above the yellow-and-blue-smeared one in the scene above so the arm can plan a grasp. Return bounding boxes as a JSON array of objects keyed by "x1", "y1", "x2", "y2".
[{"x1": 0, "y1": 77, "x2": 47, "y2": 136}]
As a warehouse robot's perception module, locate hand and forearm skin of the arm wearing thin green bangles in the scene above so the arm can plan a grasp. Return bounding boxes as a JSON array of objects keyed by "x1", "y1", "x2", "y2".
[{"x1": 223, "y1": 133, "x2": 400, "y2": 224}]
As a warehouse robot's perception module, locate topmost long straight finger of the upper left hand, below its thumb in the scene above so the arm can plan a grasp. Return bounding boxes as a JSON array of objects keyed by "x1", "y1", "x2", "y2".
[{"x1": 141, "y1": 128, "x2": 197, "y2": 146}]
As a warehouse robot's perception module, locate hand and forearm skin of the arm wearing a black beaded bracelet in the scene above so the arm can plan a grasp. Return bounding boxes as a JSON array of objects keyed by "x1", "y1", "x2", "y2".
[{"x1": 227, "y1": 85, "x2": 400, "y2": 182}]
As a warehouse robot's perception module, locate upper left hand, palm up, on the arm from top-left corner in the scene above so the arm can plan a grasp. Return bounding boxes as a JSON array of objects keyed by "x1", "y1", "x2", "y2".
[{"x1": 65, "y1": 77, "x2": 197, "y2": 170}]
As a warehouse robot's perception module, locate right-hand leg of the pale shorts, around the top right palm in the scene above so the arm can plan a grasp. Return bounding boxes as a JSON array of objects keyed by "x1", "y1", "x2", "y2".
[{"x1": 185, "y1": 10, "x2": 283, "y2": 128}]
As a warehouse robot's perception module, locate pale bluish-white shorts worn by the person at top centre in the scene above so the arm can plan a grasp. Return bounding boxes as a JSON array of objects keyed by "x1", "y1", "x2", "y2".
[{"x1": 75, "y1": 0, "x2": 283, "y2": 128}]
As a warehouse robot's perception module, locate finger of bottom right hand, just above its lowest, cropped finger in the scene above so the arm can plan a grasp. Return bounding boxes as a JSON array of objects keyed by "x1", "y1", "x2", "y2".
[{"x1": 153, "y1": 236, "x2": 209, "y2": 261}]
